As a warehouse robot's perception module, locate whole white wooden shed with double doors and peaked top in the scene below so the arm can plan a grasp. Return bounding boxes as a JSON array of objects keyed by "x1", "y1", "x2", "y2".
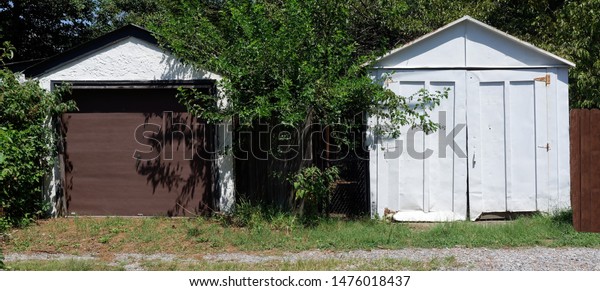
[{"x1": 368, "y1": 16, "x2": 574, "y2": 221}]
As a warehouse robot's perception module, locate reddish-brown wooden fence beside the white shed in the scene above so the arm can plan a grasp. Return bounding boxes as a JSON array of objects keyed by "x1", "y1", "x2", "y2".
[{"x1": 570, "y1": 109, "x2": 600, "y2": 232}]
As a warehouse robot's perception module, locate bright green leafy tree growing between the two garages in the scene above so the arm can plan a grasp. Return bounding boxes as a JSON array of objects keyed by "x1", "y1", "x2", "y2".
[{"x1": 151, "y1": 0, "x2": 444, "y2": 210}]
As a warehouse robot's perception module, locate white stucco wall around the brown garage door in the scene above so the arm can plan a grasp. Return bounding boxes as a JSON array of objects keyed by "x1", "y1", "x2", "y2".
[{"x1": 37, "y1": 37, "x2": 235, "y2": 215}]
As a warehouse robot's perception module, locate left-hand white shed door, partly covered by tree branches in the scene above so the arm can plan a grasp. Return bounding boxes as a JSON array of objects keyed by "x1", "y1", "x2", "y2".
[{"x1": 372, "y1": 70, "x2": 467, "y2": 221}]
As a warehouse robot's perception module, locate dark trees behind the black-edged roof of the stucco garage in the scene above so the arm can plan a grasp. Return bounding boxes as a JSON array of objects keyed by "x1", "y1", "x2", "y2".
[{"x1": 0, "y1": 0, "x2": 164, "y2": 66}]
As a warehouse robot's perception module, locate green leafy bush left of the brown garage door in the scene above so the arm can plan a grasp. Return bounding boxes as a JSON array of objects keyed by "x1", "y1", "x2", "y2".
[{"x1": 0, "y1": 43, "x2": 75, "y2": 232}]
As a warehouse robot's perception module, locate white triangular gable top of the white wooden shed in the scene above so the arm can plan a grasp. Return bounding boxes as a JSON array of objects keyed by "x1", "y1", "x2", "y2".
[{"x1": 371, "y1": 16, "x2": 575, "y2": 68}]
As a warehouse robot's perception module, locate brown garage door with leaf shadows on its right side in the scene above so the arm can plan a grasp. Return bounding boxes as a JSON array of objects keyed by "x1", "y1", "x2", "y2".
[{"x1": 62, "y1": 89, "x2": 212, "y2": 216}]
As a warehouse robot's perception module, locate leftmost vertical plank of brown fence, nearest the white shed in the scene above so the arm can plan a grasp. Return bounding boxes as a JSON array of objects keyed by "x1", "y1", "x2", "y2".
[{"x1": 570, "y1": 109, "x2": 581, "y2": 231}]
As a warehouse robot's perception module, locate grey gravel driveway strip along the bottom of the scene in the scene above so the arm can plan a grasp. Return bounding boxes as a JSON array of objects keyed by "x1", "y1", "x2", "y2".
[{"x1": 5, "y1": 247, "x2": 600, "y2": 271}]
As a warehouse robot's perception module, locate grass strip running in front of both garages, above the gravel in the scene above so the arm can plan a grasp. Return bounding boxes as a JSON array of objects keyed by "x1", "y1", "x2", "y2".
[{"x1": 0, "y1": 211, "x2": 600, "y2": 257}]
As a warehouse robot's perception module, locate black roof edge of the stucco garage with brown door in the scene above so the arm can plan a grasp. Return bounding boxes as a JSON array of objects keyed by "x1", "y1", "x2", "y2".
[{"x1": 23, "y1": 24, "x2": 158, "y2": 77}]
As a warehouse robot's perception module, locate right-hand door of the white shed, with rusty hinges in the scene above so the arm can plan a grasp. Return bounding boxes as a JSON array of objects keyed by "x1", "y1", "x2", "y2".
[{"x1": 467, "y1": 69, "x2": 548, "y2": 219}]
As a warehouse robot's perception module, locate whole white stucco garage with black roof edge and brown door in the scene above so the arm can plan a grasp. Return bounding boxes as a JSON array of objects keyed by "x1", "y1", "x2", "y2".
[{"x1": 24, "y1": 25, "x2": 234, "y2": 216}]
